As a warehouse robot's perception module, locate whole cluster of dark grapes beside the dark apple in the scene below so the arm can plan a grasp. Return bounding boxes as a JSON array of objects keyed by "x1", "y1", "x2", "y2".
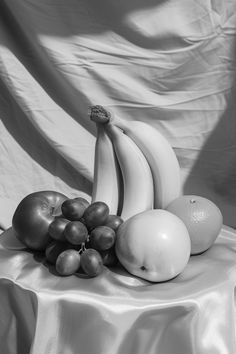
[{"x1": 45, "y1": 197, "x2": 123, "y2": 277}]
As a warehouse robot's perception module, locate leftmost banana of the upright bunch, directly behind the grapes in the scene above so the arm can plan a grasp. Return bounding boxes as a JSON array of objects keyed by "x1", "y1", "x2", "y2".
[{"x1": 91, "y1": 124, "x2": 121, "y2": 214}]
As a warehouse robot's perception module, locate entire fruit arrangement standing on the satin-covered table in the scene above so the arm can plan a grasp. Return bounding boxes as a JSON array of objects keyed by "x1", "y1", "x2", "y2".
[{"x1": 12, "y1": 106, "x2": 223, "y2": 282}]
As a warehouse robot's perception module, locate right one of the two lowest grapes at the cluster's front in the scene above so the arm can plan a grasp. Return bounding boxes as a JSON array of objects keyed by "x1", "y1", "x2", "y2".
[{"x1": 80, "y1": 248, "x2": 103, "y2": 277}]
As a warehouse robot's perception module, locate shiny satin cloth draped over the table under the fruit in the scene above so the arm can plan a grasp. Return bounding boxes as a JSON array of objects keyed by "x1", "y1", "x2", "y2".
[{"x1": 0, "y1": 227, "x2": 236, "y2": 354}]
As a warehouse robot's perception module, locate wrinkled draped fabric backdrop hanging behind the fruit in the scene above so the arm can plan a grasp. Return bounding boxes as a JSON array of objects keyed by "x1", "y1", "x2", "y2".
[{"x1": 0, "y1": 0, "x2": 236, "y2": 229}]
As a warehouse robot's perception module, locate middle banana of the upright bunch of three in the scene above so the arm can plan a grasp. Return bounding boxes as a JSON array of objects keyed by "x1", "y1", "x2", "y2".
[{"x1": 105, "y1": 123, "x2": 154, "y2": 220}]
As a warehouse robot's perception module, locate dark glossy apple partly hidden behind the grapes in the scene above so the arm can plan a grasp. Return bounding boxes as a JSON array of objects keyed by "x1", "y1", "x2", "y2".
[{"x1": 12, "y1": 191, "x2": 68, "y2": 251}]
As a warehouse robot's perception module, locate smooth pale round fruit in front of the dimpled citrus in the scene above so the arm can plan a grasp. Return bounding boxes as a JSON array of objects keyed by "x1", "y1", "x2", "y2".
[{"x1": 116, "y1": 209, "x2": 191, "y2": 282}]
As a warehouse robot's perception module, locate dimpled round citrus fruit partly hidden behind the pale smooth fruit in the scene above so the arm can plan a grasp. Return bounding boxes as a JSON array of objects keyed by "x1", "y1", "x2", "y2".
[{"x1": 166, "y1": 195, "x2": 223, "y2": 255}]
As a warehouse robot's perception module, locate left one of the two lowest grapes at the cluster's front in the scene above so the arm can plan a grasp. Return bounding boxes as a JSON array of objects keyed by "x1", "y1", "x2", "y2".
[{"x1": 56, "y1": 249, "x2": 80, "y2": 276}]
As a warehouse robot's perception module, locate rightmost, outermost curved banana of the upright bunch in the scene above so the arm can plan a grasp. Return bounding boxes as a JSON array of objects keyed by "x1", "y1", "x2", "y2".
[{"x1": 109, "y1": 117, "x2": 181, "y2": 209}]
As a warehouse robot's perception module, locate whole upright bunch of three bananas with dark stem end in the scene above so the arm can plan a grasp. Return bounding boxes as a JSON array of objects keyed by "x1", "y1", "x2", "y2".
[{"x1": 90, "y1": 106, "x2": 181, "y2": 220}]
